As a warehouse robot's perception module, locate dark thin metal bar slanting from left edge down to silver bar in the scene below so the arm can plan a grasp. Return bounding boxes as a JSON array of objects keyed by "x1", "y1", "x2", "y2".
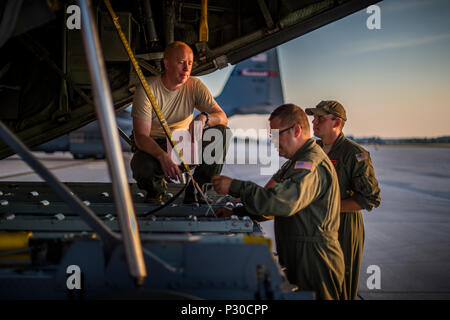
[{"x1": 0, "y1": 121, "x2": 120, "y2": 252}]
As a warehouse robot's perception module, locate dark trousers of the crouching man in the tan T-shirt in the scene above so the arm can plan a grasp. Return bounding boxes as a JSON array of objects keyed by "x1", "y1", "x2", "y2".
[{"x1": 131, "y1": 125, "x2": 231, "y2": 199}]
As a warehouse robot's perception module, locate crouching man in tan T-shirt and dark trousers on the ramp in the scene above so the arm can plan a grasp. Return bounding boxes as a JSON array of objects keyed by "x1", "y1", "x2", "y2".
[{"x1": 131, "y1": 41, "x2": 228, "y2": 203}]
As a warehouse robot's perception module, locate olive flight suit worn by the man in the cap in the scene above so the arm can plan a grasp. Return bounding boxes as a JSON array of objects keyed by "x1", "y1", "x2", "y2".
[{"x1": 319, "y1": 133, "x2": 381, "y2": 300}]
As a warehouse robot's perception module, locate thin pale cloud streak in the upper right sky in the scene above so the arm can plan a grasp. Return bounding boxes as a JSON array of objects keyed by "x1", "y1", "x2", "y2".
[{"x1": 353, "y1": 33, "x2": 450, "y2": 54}]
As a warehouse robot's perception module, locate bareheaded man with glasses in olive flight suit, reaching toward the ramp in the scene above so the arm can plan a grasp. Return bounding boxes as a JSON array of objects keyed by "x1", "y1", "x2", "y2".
[{"x1": 212, "y1": 104, "x2": 344, "y2": 299}]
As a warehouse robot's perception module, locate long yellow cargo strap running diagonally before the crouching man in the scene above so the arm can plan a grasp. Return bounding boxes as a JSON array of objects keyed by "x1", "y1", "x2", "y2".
[{"x1": 104, "y1": 0, "x2": 214, "y2": 213}]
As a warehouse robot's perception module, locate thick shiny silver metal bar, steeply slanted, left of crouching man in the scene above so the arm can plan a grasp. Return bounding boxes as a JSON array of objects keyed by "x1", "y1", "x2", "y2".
[{"x1": 78, "y1": 0, "x2": 147, "y2": 285}]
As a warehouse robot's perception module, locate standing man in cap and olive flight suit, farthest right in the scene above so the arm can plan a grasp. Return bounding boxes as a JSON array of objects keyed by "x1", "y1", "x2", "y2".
[{"x1": 305, "y1": 101, "x2": 381, "y2": 300}]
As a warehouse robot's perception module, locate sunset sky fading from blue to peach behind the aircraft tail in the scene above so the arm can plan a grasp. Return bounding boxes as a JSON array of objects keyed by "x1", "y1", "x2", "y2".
[{"x1": 200, "y1": 0, "x2": 450, "y2": 138}]
